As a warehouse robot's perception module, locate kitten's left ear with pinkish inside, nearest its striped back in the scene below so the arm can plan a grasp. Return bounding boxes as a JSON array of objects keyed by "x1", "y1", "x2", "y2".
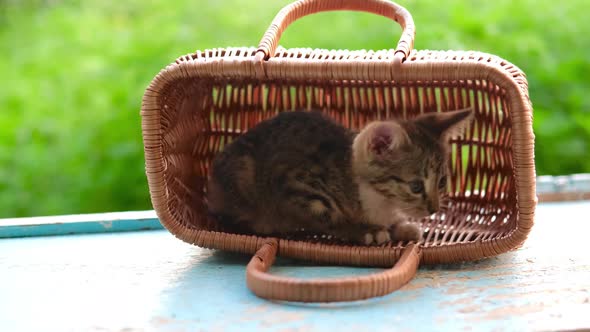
[{"x1": 369, "y1": 121, "x2": 409, "y2": 156}]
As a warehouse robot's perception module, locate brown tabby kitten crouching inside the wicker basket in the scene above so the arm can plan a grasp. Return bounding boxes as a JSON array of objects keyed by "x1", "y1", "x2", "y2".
[{"x1": 207, "y1": 110, "x2": 472, "y2": 245}]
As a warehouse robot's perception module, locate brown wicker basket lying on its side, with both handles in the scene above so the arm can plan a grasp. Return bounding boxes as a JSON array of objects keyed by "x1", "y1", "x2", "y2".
[{"x1": 141, "y1": 0, "x2": 537, "y2": 302}]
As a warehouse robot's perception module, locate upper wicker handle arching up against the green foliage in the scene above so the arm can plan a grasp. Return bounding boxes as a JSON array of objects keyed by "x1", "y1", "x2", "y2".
[{"x1": 256, "y1": 0, "x2": 416, "y2": 63}]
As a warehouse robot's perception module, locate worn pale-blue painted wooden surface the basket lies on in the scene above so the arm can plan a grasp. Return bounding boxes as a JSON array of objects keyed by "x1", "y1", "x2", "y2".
[{"x1": 0, "y1": 202, "x2": 590, "y2": 331}]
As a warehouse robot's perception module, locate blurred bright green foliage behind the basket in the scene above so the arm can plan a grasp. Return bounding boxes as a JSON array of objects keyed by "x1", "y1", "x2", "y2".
[{"x1": 0, "y1": 0, "x2": 590, "y2": 217}]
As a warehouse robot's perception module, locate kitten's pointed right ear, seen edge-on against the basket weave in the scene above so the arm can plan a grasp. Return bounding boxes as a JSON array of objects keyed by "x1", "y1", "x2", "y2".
[{"x1": 414, "y1": 108, "x2": 473, "y2": 140}]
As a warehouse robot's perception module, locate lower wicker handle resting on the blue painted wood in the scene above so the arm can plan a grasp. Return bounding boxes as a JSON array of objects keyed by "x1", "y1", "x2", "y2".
[{"x1": 246, "y1": 241, "x2": 420, "y2": 302}]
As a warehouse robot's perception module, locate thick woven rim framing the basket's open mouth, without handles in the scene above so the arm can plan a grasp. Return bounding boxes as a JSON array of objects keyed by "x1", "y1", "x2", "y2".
[{"x1": 141, "y1": 47, "x2": 537, "y2": 266}]
